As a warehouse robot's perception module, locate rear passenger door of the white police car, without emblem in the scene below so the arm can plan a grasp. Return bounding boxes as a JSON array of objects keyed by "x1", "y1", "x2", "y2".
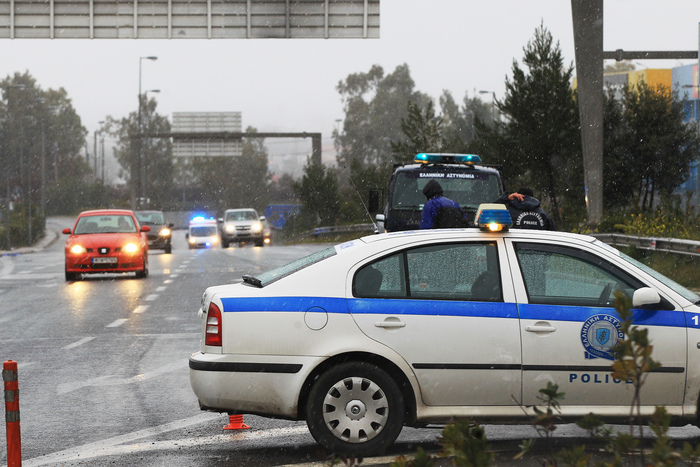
[{"x1": 348, "y1": 241, "x2": 521, "y2": 406}]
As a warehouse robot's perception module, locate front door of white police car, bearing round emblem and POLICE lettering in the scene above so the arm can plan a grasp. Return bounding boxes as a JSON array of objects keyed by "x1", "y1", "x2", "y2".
[{"x1": 507, "y1": 239, "x2": 687, "y2": 414}]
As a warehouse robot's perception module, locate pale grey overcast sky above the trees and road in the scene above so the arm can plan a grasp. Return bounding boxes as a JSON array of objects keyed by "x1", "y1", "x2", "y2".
[{"x1": 0, "y1": 0, "x2": 700, "y2": 166}]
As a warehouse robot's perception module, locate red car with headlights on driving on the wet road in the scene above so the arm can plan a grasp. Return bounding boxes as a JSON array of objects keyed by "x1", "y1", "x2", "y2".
[{"x1": 63, "y1": 209, "x2": 151, "y2": 281}]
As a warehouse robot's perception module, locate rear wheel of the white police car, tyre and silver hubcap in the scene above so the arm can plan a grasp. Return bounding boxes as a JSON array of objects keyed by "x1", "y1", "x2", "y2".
[{"x1": 306, "y1": 362, "x2": 404, "y2": 457}]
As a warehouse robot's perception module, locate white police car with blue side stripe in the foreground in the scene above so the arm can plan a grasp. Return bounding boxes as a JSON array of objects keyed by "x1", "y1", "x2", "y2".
[{"x1": 189, "y1": 205, "x2": 700, "y2": 456}]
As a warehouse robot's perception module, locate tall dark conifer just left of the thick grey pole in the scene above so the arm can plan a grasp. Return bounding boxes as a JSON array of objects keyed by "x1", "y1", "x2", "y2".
[{"x1": 477, "y1": 26, "x2": 584, "y2": 224}]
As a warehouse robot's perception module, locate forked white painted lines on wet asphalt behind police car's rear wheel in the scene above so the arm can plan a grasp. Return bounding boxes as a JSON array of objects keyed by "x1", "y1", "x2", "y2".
[{"x1": 22, "y1": 420, "x2": 309, "y2": 467}]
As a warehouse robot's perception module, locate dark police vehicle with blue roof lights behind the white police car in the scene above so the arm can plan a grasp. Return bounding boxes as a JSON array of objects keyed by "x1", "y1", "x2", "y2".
[{"x1": 369, "y1": 153, "x2": 505, "y2": 233}]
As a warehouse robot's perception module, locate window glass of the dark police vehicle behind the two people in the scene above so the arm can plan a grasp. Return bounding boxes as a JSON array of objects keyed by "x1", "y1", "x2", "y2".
[{"x1": 391, "y1": 170, "x2": 501, "y2": 210}]
